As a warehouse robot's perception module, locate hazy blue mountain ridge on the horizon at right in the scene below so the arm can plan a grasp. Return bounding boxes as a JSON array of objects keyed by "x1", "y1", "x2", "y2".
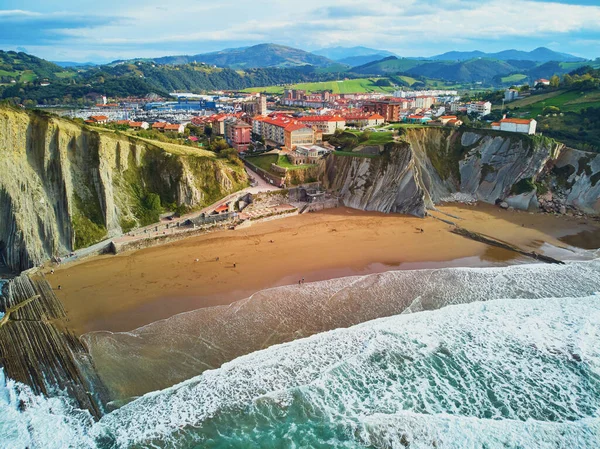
[{"x1": 429, "y1": 47, "x2": 586, "y2": 62}]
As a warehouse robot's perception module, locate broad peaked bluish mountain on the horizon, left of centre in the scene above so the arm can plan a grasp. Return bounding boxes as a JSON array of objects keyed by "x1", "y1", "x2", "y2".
[{"x1": 154, "y1": 44, "x2": 334, "y2": 69}]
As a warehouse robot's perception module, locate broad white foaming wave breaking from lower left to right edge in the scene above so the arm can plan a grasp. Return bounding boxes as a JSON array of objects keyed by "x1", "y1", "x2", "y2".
[{"x1": 95, "y1": 296, "x2": 600, "y2": 448}]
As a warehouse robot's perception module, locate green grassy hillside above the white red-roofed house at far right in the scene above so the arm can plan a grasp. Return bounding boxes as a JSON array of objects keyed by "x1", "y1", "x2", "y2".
[{"x1": 507, "y1": 90, "x2": 600, "y2": 118}]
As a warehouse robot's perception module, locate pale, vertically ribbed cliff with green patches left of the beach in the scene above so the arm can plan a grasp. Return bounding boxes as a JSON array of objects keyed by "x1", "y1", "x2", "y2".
[{"x1": 0, "y1": 108, "x2": 246, "y2": 271}]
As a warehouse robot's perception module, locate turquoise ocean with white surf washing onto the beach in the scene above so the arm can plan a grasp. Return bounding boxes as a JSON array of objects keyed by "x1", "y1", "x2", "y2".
[{"x1": 0, "y1": 261, "x2": 600, "y2": 449}]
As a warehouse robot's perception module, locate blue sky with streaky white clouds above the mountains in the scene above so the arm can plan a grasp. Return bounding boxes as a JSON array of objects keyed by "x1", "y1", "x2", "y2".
[{"x1": 0, "y1": 0, "x2": 600, "y2": 62}]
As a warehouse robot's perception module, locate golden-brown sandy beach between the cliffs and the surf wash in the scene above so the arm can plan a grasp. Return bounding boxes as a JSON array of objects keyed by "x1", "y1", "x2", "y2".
[{"x1": 47, "y1": 205, "x2": 599, "y2": 334}]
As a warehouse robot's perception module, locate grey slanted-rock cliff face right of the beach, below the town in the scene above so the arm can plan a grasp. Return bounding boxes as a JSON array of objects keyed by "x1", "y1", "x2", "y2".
[{"x1": 323, "y1": 128, "x2": 600, "y2": 216}]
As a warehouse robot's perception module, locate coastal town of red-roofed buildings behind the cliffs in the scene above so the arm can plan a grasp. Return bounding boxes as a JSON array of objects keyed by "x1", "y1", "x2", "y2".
[{"x1": 75, "y1": 84, "x2": 547, "y2": 186}]
